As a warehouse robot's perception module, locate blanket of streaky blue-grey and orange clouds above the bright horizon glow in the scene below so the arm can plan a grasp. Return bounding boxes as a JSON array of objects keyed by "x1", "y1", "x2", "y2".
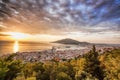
[{"x1": 0, "y1": 0, "x2": 120, "y2": 34}]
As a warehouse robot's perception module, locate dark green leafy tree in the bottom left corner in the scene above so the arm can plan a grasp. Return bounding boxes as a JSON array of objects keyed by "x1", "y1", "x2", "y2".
[{"x1": 0, "y1": 54, "x2": 22, "y2": 80}]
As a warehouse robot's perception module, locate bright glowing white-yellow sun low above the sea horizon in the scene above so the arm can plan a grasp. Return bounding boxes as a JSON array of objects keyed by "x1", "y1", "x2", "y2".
[{"x1": 8, "y1": 32, "x2": 28, "y2": 40}]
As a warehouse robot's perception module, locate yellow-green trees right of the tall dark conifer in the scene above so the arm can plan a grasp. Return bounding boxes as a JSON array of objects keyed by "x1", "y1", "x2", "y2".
[{"x1": 100, "y1": 49, "x2": 120, "y2": 80}]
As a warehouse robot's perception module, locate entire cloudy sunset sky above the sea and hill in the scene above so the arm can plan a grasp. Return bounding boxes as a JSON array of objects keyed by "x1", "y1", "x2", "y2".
[{"x1": 0, "y1": 0, "x2": 120, "y2": 44}]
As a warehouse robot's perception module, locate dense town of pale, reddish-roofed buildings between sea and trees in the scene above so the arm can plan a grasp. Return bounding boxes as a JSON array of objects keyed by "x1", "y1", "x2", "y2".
[{"x1": 0, "y1": 46, "x2": 119, "y2": 62}]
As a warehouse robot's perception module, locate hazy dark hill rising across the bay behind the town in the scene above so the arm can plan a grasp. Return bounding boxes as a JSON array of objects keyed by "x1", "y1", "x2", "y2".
[{"x1": 53, "y1": 38, "x2": 90, "y2": 45}]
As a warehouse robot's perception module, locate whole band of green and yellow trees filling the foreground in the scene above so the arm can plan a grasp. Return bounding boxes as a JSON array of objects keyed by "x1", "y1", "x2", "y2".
[{"x1": 0, "y1": 46, "x2": 120, "y2": 80}]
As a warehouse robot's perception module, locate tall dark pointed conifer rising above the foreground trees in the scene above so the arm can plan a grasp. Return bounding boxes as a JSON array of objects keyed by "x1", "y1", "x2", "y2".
[{"x1": 84, "y1": 45, "x2": 104, "y2": 80}]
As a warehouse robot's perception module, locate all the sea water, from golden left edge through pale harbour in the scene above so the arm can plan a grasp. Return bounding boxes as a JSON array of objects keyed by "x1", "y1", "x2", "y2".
[{"x1": 0, "y1": 41, "x2": 92, "y2": 54}]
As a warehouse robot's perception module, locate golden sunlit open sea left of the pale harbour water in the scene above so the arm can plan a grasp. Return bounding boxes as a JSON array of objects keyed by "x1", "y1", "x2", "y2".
[{"x1": 0, "y1": 41, "x2": 52, "y2": 54}]
